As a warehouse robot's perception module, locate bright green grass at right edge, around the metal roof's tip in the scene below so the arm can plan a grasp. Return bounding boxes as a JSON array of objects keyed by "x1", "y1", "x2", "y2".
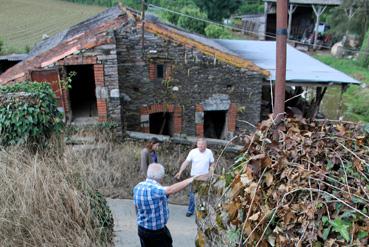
[{"x1": 316, "y1": 55, "x2": 369, "y2": 122}]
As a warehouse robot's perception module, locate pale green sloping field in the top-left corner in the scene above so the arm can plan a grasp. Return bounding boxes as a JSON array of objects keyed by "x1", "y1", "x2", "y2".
[{"x1": 0, "y1": 0, "x2": 105, "y2": 53}]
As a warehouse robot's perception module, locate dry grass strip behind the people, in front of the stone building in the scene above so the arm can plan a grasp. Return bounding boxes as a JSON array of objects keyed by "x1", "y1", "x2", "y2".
[{"x1": 64, "y1": 127, "x2": 232, "y2": 204}]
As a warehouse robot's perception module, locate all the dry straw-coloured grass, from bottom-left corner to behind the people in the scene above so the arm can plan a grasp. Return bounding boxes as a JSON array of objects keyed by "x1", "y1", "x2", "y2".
[{"x1": 0, "y1": 128, "x2": 234, "y2": 247}]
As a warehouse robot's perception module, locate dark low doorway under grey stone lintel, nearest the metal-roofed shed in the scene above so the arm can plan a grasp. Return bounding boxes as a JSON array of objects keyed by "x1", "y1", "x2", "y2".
[{"x1": 204, "y1": 111, "x2": 227, "y2": 139}]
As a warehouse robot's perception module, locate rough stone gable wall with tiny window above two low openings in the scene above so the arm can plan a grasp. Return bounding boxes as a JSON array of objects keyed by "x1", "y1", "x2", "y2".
[{"x1": 116, "y1": 25, "x2": 262, "y2": 136}]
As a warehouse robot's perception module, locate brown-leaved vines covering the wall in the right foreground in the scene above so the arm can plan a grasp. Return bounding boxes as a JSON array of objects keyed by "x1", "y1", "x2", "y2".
[{"x1": 197, "y1": 119, "x2": 369, "y2": 247}]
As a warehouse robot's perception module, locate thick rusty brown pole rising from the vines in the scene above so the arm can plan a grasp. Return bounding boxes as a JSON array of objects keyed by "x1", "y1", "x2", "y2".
[{"x1": 273, "y1": 0, "x2": 288, "y2": 122}]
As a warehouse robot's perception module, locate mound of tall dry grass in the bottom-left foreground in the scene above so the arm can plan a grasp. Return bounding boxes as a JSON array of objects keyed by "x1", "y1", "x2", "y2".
[{"x1": 0, "y1": 148, "x2": 110, "y2": 246}]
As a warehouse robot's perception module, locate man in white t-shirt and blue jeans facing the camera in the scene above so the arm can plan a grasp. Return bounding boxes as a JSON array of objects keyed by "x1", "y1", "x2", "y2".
[{"x1": 175, "y1": 138, "x2": 214, "y2": 217}]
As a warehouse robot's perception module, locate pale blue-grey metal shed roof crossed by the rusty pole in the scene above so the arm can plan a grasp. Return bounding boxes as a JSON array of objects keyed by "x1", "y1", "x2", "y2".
[{"x1": 214, "y1": 40, "x2": 360, "y2": 84}]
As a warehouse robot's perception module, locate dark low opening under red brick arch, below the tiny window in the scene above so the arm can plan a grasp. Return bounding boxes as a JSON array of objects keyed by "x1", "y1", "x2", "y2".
[{"x1": 149, "y1": 112, "x2": 173, "y2": 136}]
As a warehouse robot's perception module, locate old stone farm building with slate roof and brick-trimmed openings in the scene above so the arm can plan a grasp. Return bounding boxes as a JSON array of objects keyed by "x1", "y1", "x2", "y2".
[{"x1": 0, "y1": 6, "x2": 268, "y2": 139}]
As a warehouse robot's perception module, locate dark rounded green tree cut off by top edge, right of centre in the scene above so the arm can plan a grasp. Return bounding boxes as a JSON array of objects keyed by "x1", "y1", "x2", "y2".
[{"x1": 194, "y1": 0, "x2": 242, "y2": 21}]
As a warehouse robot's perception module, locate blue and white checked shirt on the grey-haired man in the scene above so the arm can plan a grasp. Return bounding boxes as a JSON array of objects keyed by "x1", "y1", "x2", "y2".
[{"x1": 133, "y1": 179, "x2": 169, "y2": 230}]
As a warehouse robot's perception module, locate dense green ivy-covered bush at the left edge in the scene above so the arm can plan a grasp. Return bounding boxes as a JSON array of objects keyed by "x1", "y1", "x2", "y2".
[{"x1": 0, "y1": 82, "x2": 63, "y2": 147}]
